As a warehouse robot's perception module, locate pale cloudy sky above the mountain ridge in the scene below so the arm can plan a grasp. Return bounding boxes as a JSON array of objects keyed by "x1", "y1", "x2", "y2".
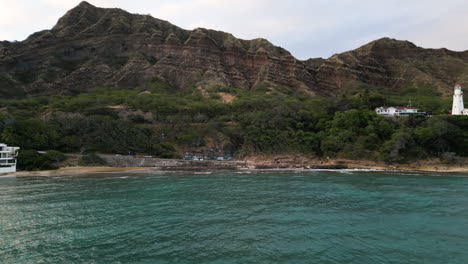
[{"x1": 0, "y1": 0, "x2": 468, "y2": 59}]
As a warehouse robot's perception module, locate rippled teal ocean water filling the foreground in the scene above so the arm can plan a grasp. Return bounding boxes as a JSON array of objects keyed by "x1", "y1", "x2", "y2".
[{"x1": 0, "y1": 172, "x2": 468, "y2": 264}]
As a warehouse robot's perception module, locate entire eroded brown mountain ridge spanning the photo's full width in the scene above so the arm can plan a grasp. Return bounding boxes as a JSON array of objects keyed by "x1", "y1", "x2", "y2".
[{"x1": 0, "y1": 2, "x2": 468, "y2": 98}]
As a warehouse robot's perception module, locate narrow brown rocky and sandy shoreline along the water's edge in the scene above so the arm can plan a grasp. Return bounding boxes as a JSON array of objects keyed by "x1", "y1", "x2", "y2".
[{"x1": 3, "y1": 155, "x2": 468, "y2": 177}]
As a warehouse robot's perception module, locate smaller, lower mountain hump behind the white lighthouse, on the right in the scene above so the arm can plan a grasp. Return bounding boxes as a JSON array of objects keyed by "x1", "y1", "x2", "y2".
[{"x1": 315, "y1": 38, "x2": 468, "y2": 95}]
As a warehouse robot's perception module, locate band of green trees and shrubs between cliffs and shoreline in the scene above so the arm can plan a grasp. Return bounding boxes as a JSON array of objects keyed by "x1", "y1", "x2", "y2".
[{"x1": 0, "y1": 79, "x2": 468, "y2": 169}]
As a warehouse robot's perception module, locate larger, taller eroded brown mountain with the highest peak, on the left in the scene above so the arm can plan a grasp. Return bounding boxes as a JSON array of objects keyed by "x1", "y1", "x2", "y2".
[{"x1": 0, "y1": 2, "x2": 321, "y2": 95}]
